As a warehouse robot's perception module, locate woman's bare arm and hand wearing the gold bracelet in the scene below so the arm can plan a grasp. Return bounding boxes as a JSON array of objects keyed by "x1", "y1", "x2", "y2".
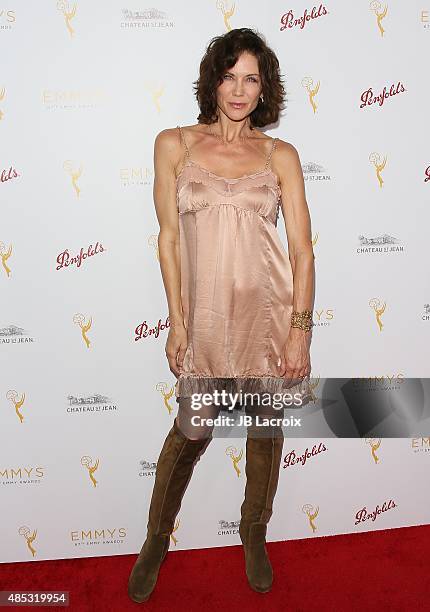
[{"x1": 273, "y1": 140, "x2": 315, "y2": 378}]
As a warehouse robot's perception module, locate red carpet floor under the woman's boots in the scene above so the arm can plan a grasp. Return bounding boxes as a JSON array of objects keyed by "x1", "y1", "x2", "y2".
[{"x1": 0, "y1": 525, "x2": 430, "y2": 612}]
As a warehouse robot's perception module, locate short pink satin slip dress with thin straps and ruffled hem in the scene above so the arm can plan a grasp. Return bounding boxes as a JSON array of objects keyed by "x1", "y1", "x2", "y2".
[{"x1": 175, "y1": 126, "x2": 309, "y2": 401}]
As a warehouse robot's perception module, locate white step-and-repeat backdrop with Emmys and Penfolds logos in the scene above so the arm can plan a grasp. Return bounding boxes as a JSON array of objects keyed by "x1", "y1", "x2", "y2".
[{"x1": 0, "y1": 0, "x2": 430, "y2": 562}]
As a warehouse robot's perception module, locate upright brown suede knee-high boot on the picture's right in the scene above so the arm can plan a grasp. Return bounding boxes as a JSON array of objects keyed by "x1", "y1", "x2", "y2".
[{"x1": 239, "y1": 424, "x2": 284, "y2": 593}]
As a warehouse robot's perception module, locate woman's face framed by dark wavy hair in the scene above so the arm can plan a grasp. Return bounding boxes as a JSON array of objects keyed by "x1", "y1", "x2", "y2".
[{"x1": 217, "y1": 51, "x2": 262, "y2": 121}]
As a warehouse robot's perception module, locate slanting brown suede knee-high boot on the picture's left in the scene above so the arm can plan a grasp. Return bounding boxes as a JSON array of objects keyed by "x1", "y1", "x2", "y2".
[{"x1": 128, "y1": 419, "x2": 212, "y2": 603}]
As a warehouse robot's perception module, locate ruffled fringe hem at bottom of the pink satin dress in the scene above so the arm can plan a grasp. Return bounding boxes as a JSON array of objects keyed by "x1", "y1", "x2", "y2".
[{"x1": 175, "y1": 375, "x2": 315, "y2": 408}]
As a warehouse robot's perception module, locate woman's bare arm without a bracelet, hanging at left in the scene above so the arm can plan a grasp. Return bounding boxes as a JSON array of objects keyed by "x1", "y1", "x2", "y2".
[{"x1": 153, "y1": 128, "x2": 187, "y2": 376}]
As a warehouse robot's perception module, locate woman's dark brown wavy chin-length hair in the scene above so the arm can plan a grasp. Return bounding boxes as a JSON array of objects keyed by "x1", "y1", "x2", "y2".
[{"x1": 193, "y1": 28, "x2": 285, "y2": 128}]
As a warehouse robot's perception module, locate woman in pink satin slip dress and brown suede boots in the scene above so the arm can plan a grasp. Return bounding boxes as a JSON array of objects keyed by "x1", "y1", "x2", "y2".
[{"x1": 128, "y1": 28, "x2": 314, "y2": 602}]
